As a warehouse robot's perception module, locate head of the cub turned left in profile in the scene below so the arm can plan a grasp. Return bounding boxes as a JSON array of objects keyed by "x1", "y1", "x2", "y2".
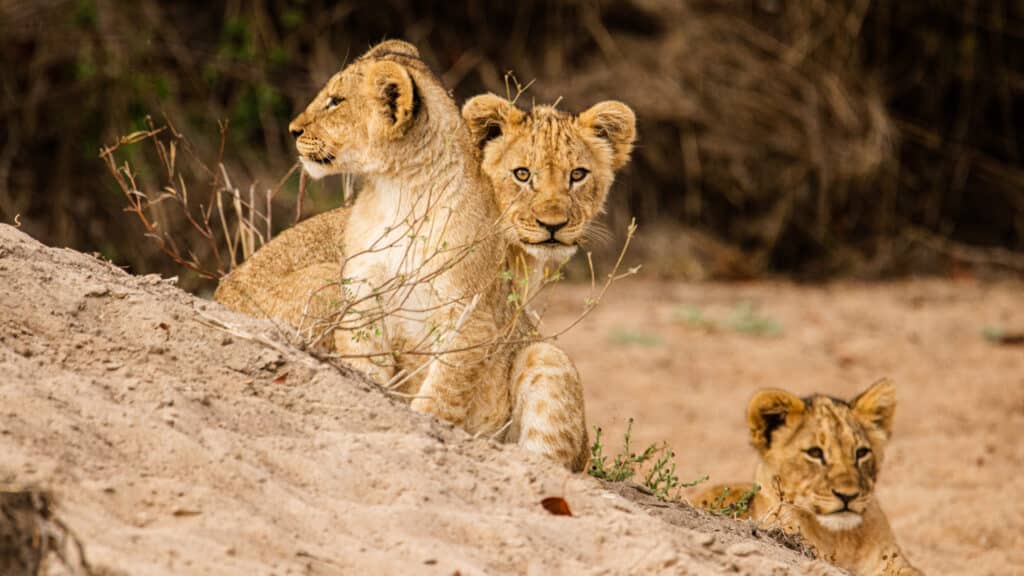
[{"x1": 288, "y1": 40, "x2": 434, "y2": 178}]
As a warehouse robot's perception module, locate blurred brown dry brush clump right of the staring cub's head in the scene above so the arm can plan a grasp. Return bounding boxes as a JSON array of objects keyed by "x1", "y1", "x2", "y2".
[{"x1": 524, "y1": 2, "x2": 895, "y2": 275}]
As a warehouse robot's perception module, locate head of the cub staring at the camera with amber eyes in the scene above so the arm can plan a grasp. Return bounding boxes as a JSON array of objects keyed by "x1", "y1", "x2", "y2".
[{"x1": 462, "y1": 94, "x2": 636, "y2": 260}]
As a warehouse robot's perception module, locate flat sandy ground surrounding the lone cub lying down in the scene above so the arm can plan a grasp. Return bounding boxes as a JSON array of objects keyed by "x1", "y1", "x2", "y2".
[{"x1": 544, "y1": 278, "x2": 1024, "y2": 575}]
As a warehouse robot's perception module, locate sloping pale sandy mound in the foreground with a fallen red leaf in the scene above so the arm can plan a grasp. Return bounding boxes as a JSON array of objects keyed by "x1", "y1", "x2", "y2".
[{"x1": 0, "y1": 225, "x2": 834, "y2": 575}]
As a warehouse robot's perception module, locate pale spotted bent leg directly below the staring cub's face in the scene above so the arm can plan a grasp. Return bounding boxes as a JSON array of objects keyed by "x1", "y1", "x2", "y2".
[{"x1": 508, "y1": 342, "x2": 589, "y2": 471}]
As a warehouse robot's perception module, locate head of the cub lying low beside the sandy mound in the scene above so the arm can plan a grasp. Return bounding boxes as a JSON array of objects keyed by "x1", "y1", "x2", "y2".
[{"x1": 746, "y1": 380, "x2": 896, "y2": 531}]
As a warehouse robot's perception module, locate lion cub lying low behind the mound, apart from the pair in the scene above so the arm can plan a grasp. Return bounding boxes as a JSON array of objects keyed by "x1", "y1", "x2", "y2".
[{"x1": 697, "y1": 380, "x2": 921, "y2": 576}]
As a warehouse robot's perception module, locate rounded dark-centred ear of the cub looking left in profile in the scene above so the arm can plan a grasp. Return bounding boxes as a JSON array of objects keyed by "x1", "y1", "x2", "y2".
[{"x1": 366, "y1": 60, "x2": 419, "y2": 138}]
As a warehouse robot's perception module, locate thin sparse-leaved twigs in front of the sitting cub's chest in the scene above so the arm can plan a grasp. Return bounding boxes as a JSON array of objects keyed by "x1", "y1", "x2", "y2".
[{"x1": 286, "y1": 208, "x2": 640, "y2": 391}]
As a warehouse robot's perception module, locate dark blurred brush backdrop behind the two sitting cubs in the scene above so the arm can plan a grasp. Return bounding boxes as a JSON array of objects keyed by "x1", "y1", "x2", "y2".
[{"x1": 0, "y1": 0, "x2": 1024, "y2": 291}]
